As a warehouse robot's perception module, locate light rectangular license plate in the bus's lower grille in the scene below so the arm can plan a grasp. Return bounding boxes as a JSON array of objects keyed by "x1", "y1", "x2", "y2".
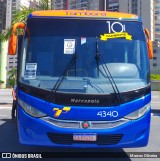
[{"x1": 73, "y1": 133, "x2": 97, "y2": 141}]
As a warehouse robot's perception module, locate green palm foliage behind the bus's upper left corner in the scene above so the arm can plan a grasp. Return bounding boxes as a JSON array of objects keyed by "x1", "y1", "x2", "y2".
[{"x1": 0, "y1": 0, "x2": 51, "y2": 41}]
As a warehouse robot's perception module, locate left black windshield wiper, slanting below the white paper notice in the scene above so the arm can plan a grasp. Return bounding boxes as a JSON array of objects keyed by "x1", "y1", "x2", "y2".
[{"x1": 52, "y1": 54, "x2": 77, "y2": 95}]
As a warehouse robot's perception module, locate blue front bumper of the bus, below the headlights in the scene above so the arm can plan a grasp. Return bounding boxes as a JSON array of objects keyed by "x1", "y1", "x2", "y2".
[{"x1": 18, "y1": 107, "x2": 150, "y2": 148}]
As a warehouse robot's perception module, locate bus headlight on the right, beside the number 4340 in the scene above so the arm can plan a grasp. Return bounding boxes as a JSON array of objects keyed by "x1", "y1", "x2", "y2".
[{"x1": 125, "y1": 103, "x2": 151, "y2": 120}]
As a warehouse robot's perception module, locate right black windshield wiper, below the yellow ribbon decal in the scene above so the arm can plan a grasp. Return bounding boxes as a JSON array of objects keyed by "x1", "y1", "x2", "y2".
[{"x1": 95, "y1": 37, "x2": 122, "y2": 105}]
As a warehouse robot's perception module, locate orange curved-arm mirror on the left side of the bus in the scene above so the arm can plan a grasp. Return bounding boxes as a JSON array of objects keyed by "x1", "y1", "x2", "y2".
[{"x1": 8, "y1": 22, "x2": 25, "y2": 55}]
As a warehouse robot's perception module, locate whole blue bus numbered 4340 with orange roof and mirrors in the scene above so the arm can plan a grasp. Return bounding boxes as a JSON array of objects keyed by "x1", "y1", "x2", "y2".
[{"x1": 9, "y1": 10, "x2": 153, "y2": 148}]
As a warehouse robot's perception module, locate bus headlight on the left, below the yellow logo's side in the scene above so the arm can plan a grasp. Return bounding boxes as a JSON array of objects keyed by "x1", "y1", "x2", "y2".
[{"x1": 18, "y1": 99, "x2": 46, "y2": 117}]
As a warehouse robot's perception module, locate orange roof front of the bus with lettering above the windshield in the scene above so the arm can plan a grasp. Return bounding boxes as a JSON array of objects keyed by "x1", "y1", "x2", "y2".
[{"x1": 28, "y1": 10, "x2": 140, "y2": 21}]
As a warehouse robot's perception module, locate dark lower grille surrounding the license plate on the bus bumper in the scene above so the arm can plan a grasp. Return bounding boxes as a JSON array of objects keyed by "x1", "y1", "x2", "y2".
[{"x1": 47, "y1": 133, "x2": 123, "y2": 145}]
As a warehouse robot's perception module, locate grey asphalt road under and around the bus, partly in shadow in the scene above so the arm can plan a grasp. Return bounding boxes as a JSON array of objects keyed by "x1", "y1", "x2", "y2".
[{"x1": 0, "y1": 91, "x2": 160, "y2": 161}]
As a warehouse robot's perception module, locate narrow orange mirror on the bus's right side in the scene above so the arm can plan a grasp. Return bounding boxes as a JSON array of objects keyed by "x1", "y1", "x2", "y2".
[{"x1": 144, "y1": 29, "x2": 153, "y2": 59}]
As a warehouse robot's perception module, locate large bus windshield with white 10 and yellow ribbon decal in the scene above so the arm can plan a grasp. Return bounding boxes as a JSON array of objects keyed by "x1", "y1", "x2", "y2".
[{"x1": 19, "y1": 18, "x2": 149, "y2": 94}]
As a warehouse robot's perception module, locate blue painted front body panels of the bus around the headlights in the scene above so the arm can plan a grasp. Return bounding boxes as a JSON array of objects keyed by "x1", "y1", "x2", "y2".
[{"x1": 18, "y1": 91, "x2": 151, "y2": 148}]
